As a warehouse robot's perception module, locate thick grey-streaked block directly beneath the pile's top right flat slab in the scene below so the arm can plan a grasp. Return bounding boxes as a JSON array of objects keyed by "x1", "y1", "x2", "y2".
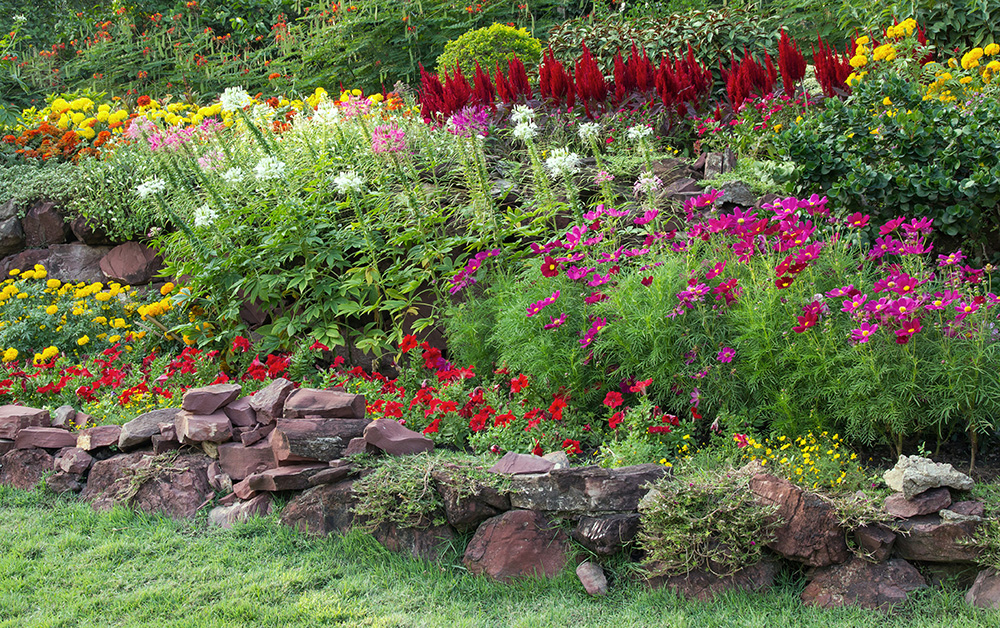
[{"x1": 270, "y1": 419, "x2": 369, "y2": 461}]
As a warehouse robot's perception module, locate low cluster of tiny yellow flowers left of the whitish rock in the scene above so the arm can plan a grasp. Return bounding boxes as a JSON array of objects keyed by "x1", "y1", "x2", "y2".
[{"x1": 743, "y1": 431, "x2": 864, "y2": 488}]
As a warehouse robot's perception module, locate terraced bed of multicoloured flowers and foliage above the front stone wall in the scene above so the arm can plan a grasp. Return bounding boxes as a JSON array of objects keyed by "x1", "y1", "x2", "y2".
[{"x1": 0, "y1": 2, "x2": 1000, "y2": 620}]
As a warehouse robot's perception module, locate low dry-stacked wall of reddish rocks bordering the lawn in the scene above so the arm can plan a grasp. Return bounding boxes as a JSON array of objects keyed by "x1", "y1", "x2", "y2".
[{"x1": 0, "y1": 379, "x2": 1000, "y2": 609}]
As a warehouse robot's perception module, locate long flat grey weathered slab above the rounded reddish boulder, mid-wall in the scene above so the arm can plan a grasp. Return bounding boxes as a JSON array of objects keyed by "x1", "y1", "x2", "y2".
[{"x1": 510, "y1": 464, "x2": 667, "y2": 515}]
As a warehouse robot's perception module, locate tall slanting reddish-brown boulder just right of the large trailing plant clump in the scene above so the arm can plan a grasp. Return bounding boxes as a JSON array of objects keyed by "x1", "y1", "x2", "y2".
[{"x1": 750, "y1": 473, "x2": 849, "y2": 567}]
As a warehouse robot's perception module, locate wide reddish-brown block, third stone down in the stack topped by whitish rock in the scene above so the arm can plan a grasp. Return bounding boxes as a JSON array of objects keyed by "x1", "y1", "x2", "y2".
[{"x1": 896, "y1": 515, "x2": 978, "y2": 563}]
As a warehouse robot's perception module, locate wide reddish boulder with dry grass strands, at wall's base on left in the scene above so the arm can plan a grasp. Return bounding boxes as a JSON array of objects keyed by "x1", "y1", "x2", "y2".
[{"x1": 81, "y1": 452, "x2": 214, "y2": 519}]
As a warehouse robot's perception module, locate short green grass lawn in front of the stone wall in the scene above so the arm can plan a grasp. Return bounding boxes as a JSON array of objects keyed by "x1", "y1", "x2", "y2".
[{"x1": 0, "y1": 487, "x2": 1000, "y2": 628}]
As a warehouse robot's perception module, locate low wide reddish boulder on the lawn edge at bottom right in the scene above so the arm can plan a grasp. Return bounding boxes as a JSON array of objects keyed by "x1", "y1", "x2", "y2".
[{"x1": 800, "y1": 557, "x2": 927, "y2": 609}]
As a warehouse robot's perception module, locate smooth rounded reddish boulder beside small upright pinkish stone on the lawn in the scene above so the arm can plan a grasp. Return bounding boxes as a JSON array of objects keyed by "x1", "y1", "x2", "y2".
[{"x1": 462, "y1": 510, "x2": 572, "y2": 582}]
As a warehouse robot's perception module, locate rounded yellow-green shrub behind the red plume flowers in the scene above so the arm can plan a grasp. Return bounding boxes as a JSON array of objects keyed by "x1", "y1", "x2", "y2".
[{"x1": 437, "y1": 24, "x2": 542, "y2": 77}]
